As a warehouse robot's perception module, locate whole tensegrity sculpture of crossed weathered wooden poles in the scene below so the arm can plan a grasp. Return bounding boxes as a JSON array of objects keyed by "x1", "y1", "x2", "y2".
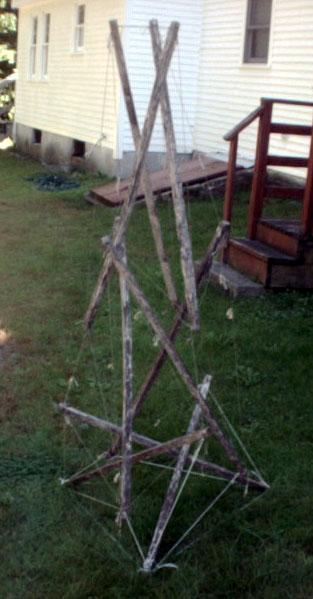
[{"x1": 59, "y1": 21, "x2": 268, "y2": 571}]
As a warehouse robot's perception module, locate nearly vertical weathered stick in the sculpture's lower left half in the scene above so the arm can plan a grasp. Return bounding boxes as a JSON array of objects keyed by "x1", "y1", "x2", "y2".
[{"x1": 118, "y1": 244, "x2": 133, "y2": 526}]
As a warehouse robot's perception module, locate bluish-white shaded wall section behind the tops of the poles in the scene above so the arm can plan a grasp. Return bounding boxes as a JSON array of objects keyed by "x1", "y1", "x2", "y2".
[{"x1": 120, "y1": 0, "x2": 202, "y2": 157}]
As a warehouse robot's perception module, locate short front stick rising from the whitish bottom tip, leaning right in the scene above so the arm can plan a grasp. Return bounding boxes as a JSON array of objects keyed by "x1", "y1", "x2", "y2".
[{"x1": 143, "y1": 377, "x2": 211, "y2": 572}]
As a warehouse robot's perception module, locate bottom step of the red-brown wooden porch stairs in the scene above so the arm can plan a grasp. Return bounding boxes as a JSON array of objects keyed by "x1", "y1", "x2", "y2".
[{"x1": 227, "y1": 238, "x2": 297, "y2": 287}]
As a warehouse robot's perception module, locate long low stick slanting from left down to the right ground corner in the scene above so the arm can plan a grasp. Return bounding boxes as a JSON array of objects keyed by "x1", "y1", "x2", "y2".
[{"x1": 58, "y1": 403, "x2": 268, "y2": 491}]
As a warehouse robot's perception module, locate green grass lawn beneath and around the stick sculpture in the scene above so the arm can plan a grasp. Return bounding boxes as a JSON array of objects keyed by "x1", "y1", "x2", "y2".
[{"x1": 0, "y1": 153, "x2": 313, "y2": 599}]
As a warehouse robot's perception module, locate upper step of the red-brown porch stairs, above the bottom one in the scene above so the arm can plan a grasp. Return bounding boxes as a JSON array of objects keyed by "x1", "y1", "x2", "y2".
[{"x1": 256, "y1": 218, "x2": 302, "y2": 258}]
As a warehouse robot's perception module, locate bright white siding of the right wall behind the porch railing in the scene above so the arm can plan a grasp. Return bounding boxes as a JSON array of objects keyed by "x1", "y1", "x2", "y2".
[{"x1": 194, "y1": 0, "x2": 313, "y2": 173}]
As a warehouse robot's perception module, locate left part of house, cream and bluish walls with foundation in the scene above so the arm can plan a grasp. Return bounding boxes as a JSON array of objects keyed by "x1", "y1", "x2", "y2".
[{"x1": 14, "y1": 0, "x2": 202, "y2": 175}]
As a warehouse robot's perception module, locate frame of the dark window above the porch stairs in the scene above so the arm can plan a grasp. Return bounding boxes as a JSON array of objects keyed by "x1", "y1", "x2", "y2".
[{"x1": 242, "y1": 0, "x2": 274, "y2": 66}]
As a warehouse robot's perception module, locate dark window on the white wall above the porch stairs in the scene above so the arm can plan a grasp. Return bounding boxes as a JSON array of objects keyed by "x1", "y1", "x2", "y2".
[{"x1": 244, "y1": 0, "x2": 272, "y2": 63}]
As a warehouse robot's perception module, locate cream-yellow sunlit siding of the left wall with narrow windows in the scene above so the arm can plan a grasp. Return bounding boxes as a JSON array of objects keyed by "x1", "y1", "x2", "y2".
[{"x1": 16, "y1": 0, "x2": 124, "y2": 157}]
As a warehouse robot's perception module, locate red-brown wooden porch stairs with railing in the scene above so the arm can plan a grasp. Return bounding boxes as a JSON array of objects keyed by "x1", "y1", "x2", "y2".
[{"x1": 224, "y1": 98, "x2": 313, "y2": 289}]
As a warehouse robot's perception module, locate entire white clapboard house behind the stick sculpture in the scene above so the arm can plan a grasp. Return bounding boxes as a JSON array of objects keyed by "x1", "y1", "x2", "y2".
[{"x1": 13, "y1": 0, "x2": 313, "y2": 176}]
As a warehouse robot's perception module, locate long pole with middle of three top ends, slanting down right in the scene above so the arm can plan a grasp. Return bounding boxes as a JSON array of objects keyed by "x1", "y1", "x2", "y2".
[{"x1": 150, "y1": 20, "x2": 199, "y2": 329}]
